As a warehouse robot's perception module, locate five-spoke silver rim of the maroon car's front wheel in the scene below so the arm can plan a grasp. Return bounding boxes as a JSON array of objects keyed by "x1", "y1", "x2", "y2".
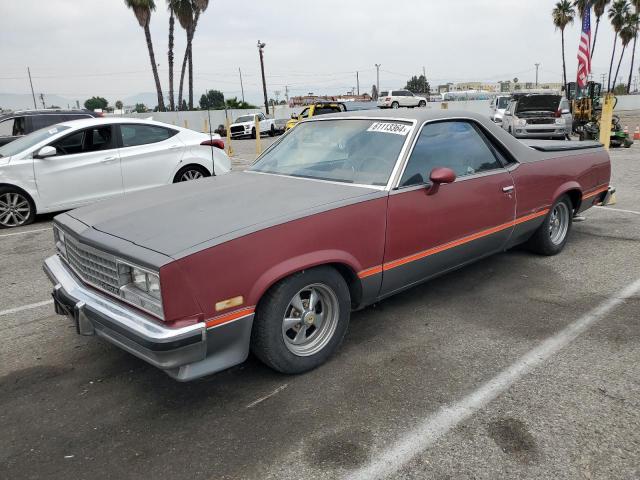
[{"x1": 282, "y1": 283, "x2": 340, "y2": 357}]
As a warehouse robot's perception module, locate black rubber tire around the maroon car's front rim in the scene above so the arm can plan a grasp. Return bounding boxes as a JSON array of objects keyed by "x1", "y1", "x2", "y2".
[{"x1": 251, "y1": 267, "x2": 351, "y2": 374}]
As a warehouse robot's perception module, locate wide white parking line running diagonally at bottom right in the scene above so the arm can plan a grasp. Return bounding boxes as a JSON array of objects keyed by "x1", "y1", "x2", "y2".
[{"x1": 344, "y1": 279, "x2": 640, "y2": 480}]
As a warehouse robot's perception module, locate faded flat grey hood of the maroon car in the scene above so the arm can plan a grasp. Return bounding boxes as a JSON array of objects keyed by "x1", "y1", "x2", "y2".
[{"x1": 68, "y1": 172, "x2": 384, "y2": 258}]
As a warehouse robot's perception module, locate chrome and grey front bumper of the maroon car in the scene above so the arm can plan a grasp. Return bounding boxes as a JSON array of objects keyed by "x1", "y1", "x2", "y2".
[{"x1": 44, "y1": 255, "x2": 253, "y2": 381}]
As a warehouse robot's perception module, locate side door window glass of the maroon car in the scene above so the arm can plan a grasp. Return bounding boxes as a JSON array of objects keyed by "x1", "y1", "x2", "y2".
[{"x1": 400, "y1": 122, "x2": 501, "y2": 187}]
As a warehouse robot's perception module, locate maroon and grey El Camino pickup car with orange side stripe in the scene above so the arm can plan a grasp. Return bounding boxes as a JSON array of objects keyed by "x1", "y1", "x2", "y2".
[{"x1": 44, "y1": 109, "x2": 612, "y2": 380}]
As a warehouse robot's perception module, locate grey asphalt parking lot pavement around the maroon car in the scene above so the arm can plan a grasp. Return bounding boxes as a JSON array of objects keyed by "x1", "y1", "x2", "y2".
[{"x1": 0, "y1": 139, "x2": 640, "y2": 480}]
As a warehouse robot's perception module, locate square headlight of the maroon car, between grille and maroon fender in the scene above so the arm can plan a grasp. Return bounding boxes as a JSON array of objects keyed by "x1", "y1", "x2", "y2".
[{"x1": 118, "y1": 260, "x2": 164, "y2": 318}]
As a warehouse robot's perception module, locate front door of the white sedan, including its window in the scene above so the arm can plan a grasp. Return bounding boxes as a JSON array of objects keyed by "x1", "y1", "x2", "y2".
[{"x1": 33, "y1": 125, "x2": 123, "y2": 209}]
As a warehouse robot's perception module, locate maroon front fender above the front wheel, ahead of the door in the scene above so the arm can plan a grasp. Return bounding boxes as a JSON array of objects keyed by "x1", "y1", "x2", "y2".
[{"x1": 170, "y1": 196, "x2": 387, "y2": 320}]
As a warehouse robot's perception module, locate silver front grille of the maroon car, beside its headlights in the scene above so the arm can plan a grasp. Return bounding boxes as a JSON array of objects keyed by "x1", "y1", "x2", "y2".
[{"x1": 65, "y1": 235, "x2": 120, "y2": 295}]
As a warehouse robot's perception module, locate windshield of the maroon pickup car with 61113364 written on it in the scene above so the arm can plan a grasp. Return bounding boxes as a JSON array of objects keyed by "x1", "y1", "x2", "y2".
[{"x1": 250, "y1": 119, "x2": 411, "y2": 186}]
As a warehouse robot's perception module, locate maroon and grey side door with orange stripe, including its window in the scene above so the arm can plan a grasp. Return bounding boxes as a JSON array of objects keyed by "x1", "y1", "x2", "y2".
[{"x1": 381, "y1": 121, "x2": 516, "y2": 295}]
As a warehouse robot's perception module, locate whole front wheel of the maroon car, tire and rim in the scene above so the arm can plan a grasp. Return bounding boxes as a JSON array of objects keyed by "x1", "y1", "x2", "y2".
[{"x1": 251, "y1": 267, "x2": 351, "y2": 374}]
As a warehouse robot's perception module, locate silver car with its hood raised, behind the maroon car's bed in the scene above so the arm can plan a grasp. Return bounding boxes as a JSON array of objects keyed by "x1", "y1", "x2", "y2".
[{"x1": 502, "y1": 94, "x2": 573, "y2": 139}]
